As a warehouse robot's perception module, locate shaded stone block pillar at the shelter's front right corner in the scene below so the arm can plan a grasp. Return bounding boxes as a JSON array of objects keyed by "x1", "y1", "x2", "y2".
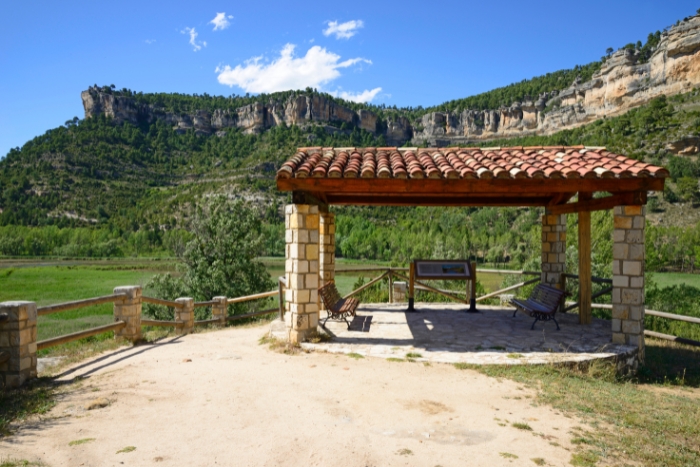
[{"x1": 612, "y1": 206, "x2": 645, "y2": 362}]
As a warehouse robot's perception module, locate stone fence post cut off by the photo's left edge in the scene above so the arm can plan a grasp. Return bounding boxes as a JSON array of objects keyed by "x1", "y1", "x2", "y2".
[{"x1": 0, "y1": 301, "x2": 37, "y2": 389}]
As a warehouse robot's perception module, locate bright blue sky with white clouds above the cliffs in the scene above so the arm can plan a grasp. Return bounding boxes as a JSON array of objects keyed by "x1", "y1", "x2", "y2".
[{"x1": 0, "y1": 0, "x2": 700, "y2": 157}]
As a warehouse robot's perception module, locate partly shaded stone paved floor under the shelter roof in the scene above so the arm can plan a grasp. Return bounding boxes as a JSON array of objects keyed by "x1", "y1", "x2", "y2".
[{"x1": 302, "y1": 303, "x2": 635, "y2": 364}]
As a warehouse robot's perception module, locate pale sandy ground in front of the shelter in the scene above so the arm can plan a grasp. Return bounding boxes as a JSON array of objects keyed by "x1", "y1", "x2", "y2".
[{"x1": 0, "y1": 327, "x2": 579, "y2": 467}]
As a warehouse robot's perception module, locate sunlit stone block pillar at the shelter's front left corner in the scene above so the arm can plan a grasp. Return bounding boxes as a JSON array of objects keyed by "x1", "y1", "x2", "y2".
[{"x1": 285, "y1": 204, "x2": 320, "y2": 343}]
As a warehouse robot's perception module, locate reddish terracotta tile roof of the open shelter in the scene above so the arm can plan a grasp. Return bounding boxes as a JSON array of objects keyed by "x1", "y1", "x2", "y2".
[{"x1": 277, "y1": 146, "x2": 669, "y2": 180}]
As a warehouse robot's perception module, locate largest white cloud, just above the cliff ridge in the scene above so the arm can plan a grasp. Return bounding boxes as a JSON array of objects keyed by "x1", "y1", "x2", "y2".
[{"x1": 215, "y1": 44, "x2": 373, "y2": 93}]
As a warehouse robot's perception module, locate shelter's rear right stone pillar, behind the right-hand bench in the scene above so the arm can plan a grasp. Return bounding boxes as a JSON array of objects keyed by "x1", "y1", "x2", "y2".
[{"x1": 541, "y1": 212, "x2": 566, "y2": 288}]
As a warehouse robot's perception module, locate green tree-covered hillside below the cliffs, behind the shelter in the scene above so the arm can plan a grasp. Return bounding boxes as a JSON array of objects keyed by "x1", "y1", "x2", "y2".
[{"x1": 0, "y1": 86, "x2": 700, "y2": 276}]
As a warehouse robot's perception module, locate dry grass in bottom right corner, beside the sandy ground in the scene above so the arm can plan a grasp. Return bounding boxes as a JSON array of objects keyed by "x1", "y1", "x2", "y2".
[{"x1": 455, "y1": 339, "x2": 700, "y2": 467}]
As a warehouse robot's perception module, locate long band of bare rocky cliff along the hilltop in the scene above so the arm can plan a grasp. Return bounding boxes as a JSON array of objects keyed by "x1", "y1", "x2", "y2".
[{"x1": 81, "y1": 15, "x2": 700, "y2": 146}]
